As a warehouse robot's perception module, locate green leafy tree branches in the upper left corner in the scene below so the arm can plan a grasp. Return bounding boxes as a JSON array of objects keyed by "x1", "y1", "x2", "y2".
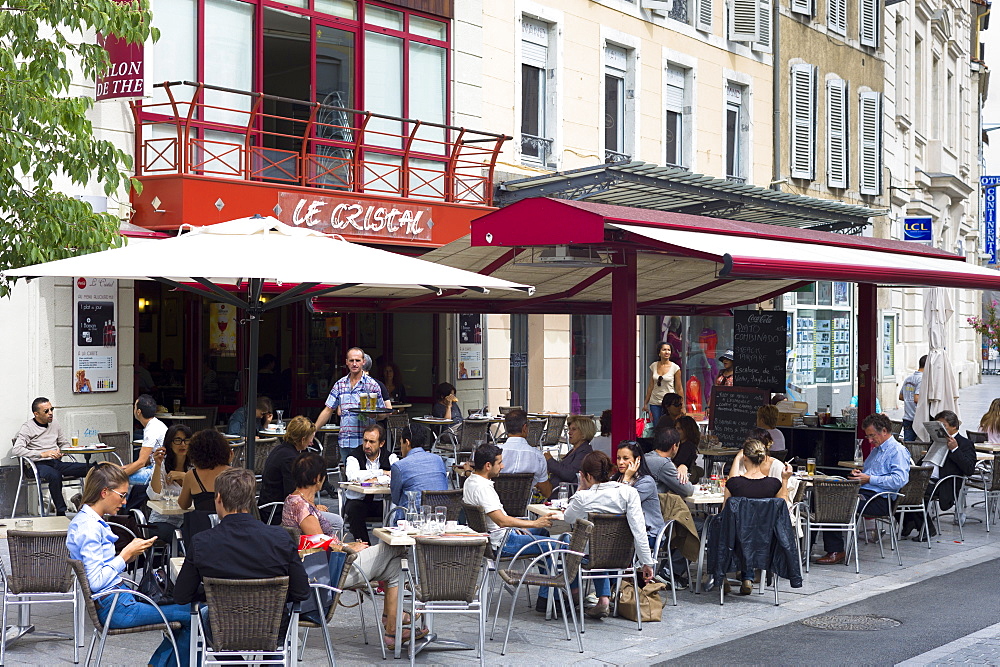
[{"x1": 0, "y1": 0, "x2": 159, "y2": 296}]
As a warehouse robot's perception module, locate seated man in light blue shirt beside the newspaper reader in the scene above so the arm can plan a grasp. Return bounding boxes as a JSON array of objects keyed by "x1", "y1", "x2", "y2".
[{"x1": 816, "y1": 414, "x2": 910, "y2": 565}]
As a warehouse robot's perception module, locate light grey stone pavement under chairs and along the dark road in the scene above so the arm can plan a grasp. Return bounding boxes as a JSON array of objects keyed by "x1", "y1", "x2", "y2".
[{"x1": 6, "y1": 377, "x2": 1000, "y2": 666}]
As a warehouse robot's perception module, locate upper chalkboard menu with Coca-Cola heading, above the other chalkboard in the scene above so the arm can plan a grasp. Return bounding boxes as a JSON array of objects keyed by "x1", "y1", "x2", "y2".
[{"x1": 733, "y1": 310, "x2": 788, "y2": 392}]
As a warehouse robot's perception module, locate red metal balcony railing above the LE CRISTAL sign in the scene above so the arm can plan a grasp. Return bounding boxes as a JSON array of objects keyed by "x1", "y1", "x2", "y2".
[{"x1": 132, "y1": 81, "x2": 510, "y2": 206}]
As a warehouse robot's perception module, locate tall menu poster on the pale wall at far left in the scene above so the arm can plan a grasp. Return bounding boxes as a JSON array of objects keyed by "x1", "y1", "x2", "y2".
[{"x1": 73, "y1": 278, "x2": 118, "y2": 394}]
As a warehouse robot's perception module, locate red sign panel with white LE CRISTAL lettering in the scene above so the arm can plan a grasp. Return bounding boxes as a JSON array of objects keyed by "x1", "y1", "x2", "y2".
[{"x1": 278, "y1": 192, "x2": 434, "y2": 241}]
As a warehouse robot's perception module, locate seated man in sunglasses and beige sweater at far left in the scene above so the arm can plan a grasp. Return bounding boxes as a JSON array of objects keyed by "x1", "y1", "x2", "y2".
[{"x1": 11, "y1": 397, "x2": 89, "y2": 516}]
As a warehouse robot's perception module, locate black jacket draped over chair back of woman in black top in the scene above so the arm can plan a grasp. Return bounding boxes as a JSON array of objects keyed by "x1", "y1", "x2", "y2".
[{"x1": 706, "y1": 497, "x2": 802, "y2": 588}]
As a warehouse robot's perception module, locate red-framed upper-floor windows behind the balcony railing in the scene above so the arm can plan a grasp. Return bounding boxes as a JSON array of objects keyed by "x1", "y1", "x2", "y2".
[{"x1": 146, "y1": 0, "x2": 450, "y2": 135}]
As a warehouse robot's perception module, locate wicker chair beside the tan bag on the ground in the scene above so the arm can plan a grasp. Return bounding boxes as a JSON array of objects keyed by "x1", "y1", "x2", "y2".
[{"x1": 580, "y1": 512, "x2": 646, "y2": 634}]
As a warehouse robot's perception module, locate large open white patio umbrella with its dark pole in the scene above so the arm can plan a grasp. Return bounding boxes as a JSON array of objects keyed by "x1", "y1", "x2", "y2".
[{"x1": 4, "y1": 215, "x2": 534, "y2": 468}]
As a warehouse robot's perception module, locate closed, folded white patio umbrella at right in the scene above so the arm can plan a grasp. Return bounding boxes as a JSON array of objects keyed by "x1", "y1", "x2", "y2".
[{"x1": 913, "y1": 287, "x2": 958, "y2": 441}]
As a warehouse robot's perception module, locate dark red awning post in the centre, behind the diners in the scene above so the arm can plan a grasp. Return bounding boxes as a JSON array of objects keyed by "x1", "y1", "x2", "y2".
[{"x1": 611, "y1": 250, "x2": 638, "y2": 460}]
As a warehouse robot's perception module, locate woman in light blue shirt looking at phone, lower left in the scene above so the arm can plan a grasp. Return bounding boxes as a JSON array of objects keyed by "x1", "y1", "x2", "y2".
[{"x1": 66, "y1": 463, "x2": 191, "y2": 667}]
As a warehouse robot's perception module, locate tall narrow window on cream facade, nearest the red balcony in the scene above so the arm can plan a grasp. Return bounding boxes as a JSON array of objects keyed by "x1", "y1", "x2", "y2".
[{"x1": 521, "y1": 16, "x2": 556, "y2": 167}]
